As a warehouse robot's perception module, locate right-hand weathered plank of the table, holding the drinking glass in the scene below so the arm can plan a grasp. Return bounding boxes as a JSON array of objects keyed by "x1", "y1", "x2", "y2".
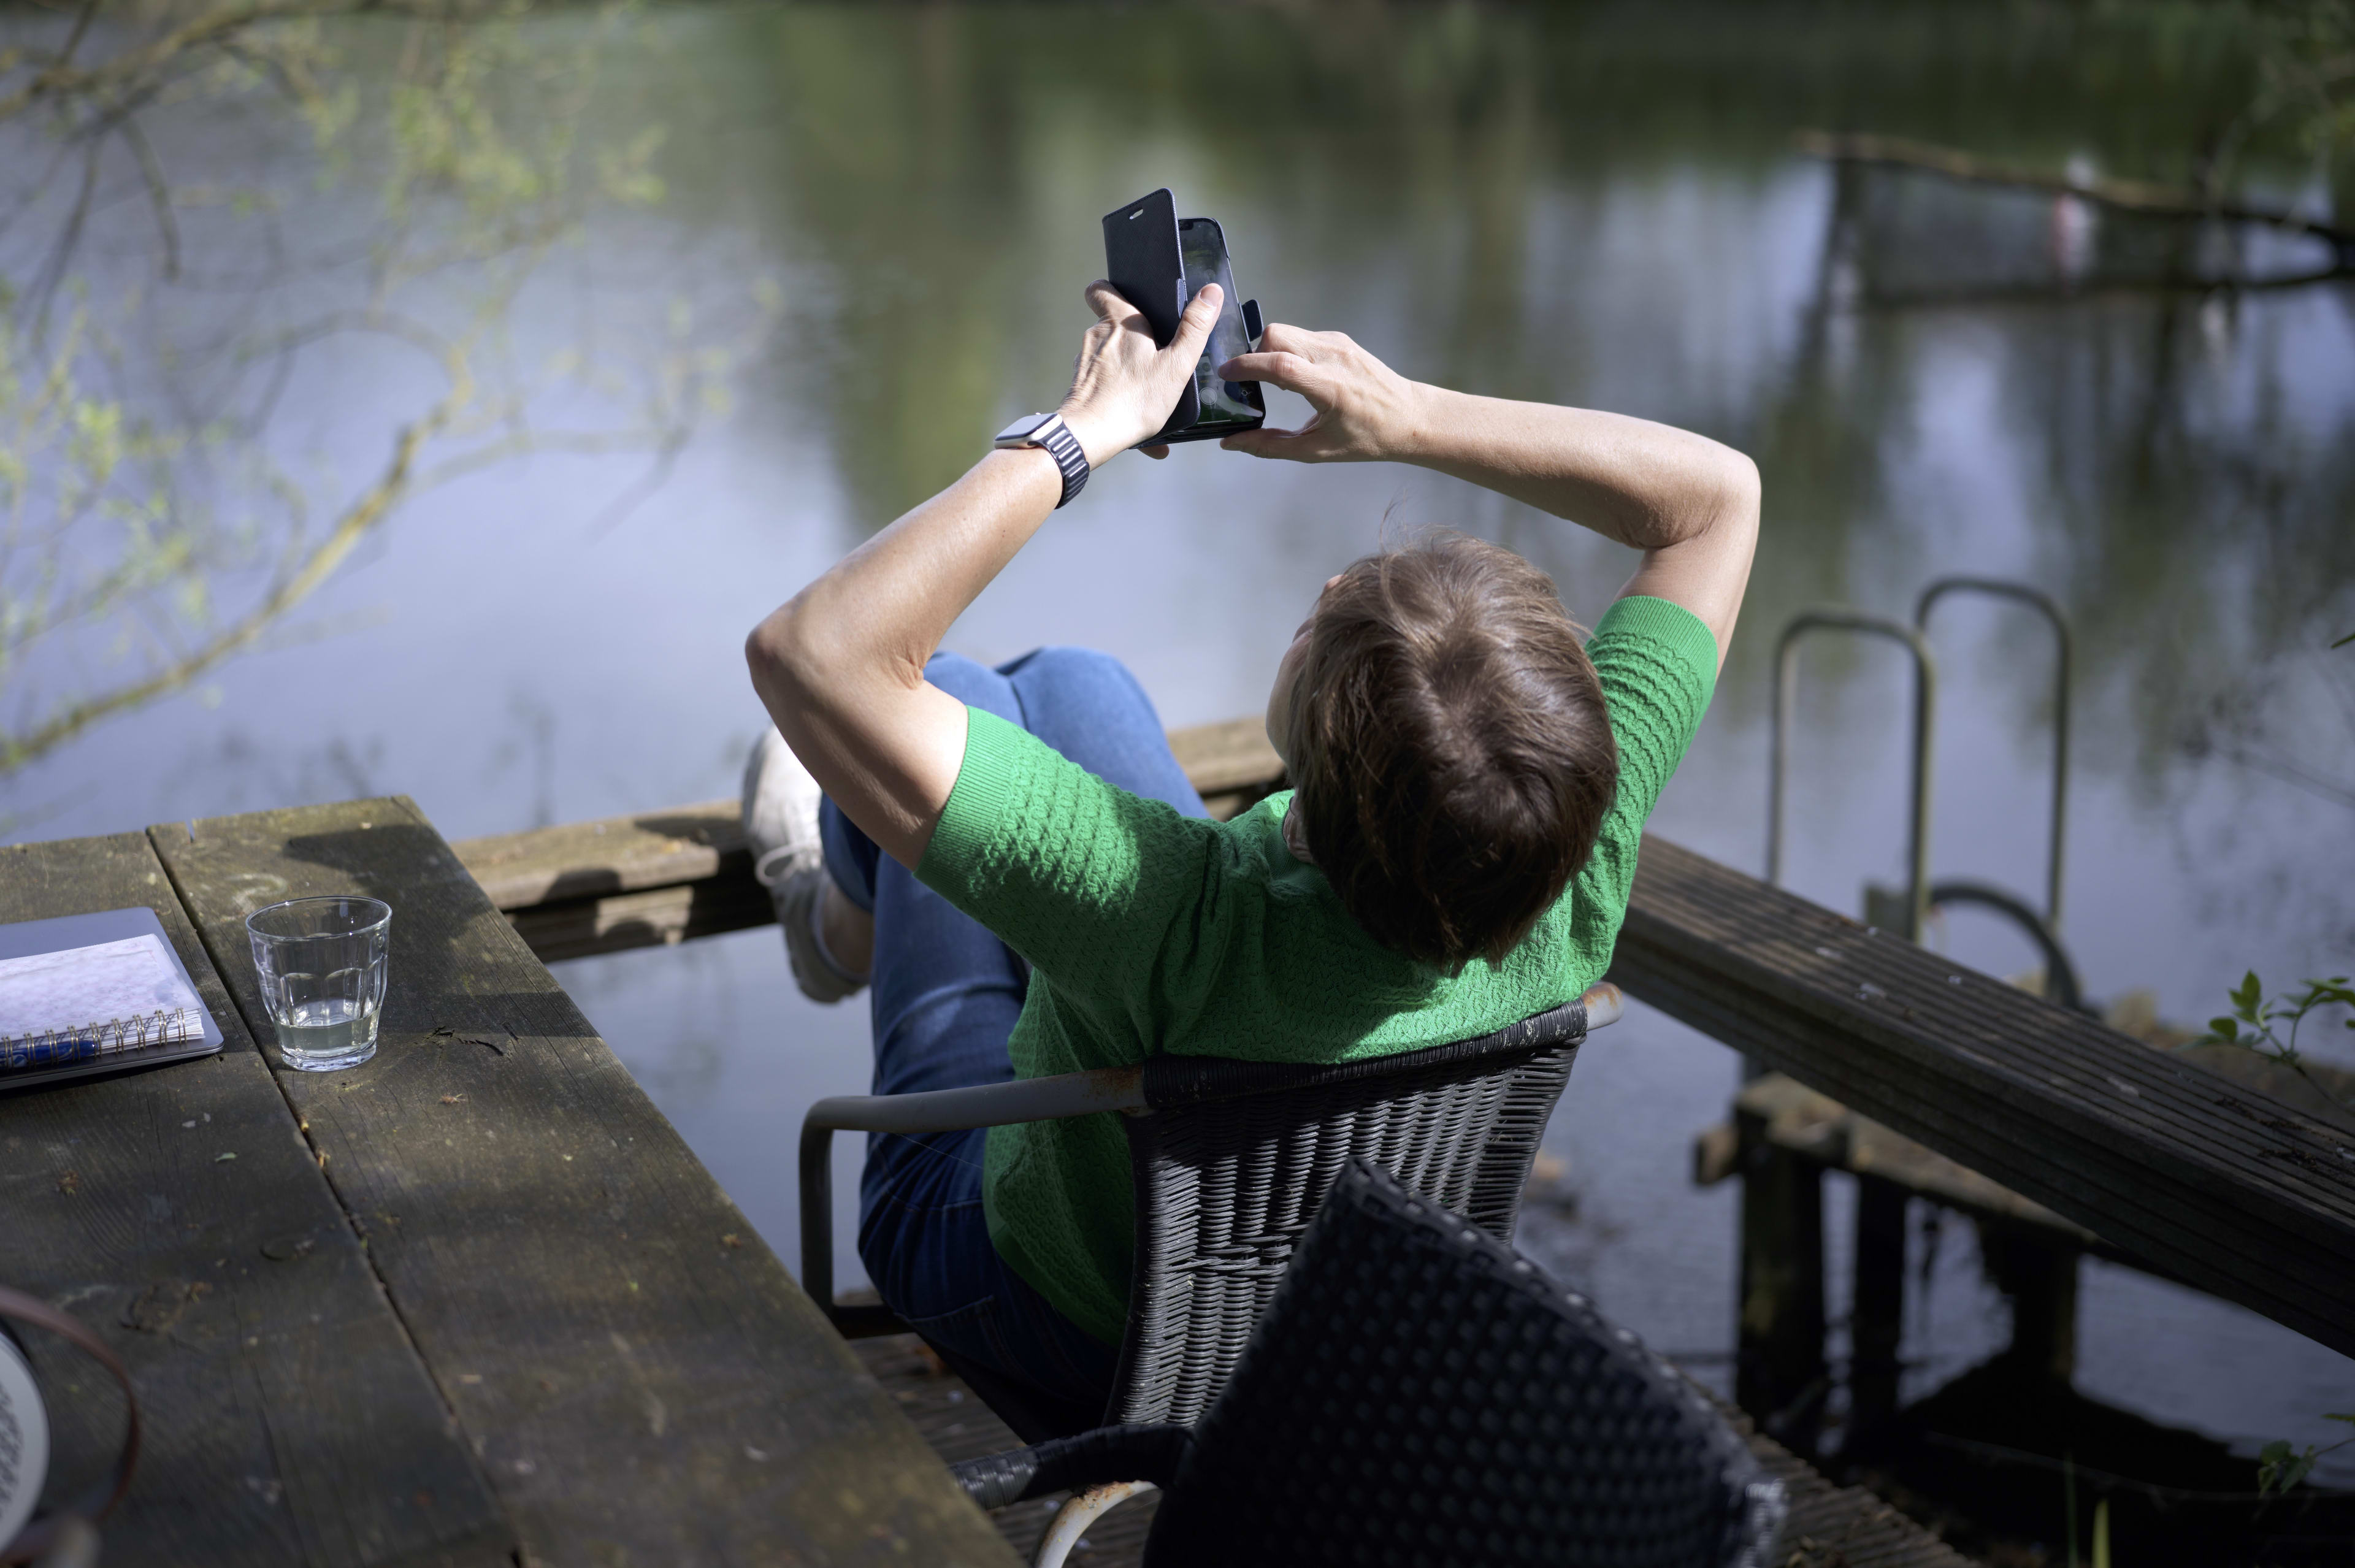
[{"x1": 153, "y1": 800, "x2": 1010, "y2": 1563}]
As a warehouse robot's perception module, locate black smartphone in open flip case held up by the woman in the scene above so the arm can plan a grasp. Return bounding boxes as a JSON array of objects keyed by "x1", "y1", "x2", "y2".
[{"x1": 1105, "y1": 188, "x2": 1267, "y2": 445}]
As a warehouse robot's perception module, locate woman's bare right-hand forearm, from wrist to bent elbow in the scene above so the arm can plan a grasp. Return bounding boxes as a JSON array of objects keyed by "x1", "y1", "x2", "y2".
[{"x1": 1396, "y1": 386, "x2": 1757, "y2": 551}]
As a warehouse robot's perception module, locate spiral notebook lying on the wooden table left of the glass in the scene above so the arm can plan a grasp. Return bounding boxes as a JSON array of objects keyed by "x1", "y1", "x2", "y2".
[{"x1": 0, "y1": 909, "x2": 221, "y2": 1092}]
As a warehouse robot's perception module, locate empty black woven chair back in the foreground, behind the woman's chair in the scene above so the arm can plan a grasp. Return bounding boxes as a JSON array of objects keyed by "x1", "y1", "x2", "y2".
[{"x1": 1144, "y1": 1161, "x2": 1785, "y2": 1568}]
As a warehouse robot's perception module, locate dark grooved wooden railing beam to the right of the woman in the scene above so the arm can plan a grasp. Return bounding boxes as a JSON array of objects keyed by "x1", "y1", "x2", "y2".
[{"x1": 1611, "y1": 838, "x2": 2355, "y2": 1354}]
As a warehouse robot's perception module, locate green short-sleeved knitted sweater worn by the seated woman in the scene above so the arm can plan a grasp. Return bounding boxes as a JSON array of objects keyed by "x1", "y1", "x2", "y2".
[{"x1": 916, "y1": 595, "x2": 1717, "y2": 1344}]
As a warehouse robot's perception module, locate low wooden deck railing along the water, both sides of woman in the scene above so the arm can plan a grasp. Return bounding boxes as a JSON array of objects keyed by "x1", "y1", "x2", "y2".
[{"x1": 454, "y1": 721, "x2": 2355, "y2": 1354}]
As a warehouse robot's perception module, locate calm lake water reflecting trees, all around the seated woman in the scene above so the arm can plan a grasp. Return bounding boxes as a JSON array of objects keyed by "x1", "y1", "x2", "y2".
[{"x1": 0, "y1": 7, "x2": 2355, "y2": 1476}]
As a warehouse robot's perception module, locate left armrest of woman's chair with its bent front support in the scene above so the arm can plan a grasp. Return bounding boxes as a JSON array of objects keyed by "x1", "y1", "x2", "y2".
[{"x1": 801, "y1": 1066, "x2": 1144, "y2": 1340}]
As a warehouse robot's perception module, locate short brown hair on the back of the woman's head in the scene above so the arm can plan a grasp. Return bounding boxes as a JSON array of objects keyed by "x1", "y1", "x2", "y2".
[{"x1": 1288, "y1": 535, "x2": 1618, "y2": 974}]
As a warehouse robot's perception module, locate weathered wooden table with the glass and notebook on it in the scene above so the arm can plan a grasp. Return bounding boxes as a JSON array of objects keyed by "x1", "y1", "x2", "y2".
[{"x1": 0, "y1": 798, "x2": 1015, "y2": 1568}]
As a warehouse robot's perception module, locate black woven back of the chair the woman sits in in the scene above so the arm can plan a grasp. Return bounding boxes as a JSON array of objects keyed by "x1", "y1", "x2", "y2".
[{"x1": 1105, "y1": 1001, "x2": 1587, "y2": 1425}]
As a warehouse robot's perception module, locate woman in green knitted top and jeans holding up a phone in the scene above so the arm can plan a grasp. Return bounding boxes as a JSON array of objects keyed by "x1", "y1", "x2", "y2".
[{"x1": 744, "y1": 283, "x2": 1759, "y2": 1408}]
